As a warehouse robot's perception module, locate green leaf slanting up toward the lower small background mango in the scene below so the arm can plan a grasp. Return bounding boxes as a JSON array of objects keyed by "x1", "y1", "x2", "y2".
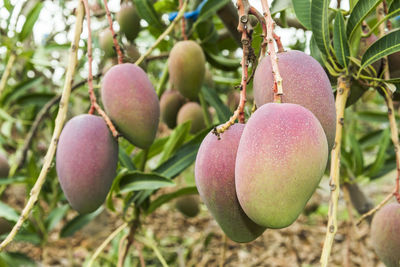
[{"x1": 158, "y1": 121, "x2": 191, "y2": 165}]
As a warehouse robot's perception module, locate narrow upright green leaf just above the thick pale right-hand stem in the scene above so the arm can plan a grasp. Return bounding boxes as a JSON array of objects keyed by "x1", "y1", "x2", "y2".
[{"x1": 333, "y1": 11, "x2": 350, "y2": 69}]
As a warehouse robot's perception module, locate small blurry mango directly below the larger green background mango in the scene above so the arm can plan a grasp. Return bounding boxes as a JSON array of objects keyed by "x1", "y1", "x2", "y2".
[{"x1": 177, "y1": 102, "x2": 206, "y2": 134}]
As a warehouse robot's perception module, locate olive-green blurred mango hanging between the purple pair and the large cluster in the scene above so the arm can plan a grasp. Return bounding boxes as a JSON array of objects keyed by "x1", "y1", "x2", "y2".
[{"x1": 168, "y1": 40, "x2": 206, "y2": 100}]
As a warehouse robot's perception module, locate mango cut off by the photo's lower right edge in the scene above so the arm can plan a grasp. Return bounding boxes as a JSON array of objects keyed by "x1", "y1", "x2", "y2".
[{"x1": 371, "y1": 203, "x2": 400, "y2": 267}]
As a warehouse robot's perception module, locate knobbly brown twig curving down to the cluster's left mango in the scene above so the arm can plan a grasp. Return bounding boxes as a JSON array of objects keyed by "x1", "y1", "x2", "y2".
[{"x1": 213, "y1": 0, "x2": 253, "y2": 137}]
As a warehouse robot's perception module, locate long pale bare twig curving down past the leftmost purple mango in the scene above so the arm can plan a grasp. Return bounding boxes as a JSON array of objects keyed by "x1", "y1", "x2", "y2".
[{"x1": 0, "y1": 2, "x2": 84, "y2": 251}]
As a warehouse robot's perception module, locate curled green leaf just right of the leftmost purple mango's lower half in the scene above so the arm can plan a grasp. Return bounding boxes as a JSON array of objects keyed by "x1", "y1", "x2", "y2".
[{"x1": 119, "y1": 171, "x2": 175, "y2": 193}]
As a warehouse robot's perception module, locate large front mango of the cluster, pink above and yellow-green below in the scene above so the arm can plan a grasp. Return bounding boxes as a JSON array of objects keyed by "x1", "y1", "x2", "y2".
[{"x1": 235, "y1": 103, "x2": 328, "y2": 229}]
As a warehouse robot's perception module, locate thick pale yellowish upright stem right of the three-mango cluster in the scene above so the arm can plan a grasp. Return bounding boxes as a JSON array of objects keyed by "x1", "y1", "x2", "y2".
[{"x1": 320, "y1": 75, "x2": 350, "y2": 267}]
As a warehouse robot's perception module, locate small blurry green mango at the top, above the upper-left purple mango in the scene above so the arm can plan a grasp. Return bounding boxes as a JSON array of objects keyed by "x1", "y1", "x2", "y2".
[{"x1": 117, "y1": 2, "x2": 140, "y2": 42}]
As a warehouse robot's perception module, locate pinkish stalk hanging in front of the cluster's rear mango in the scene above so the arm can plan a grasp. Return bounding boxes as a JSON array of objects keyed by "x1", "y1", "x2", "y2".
[{"x1": 261, "y1": 0, "x2": 283, "y2": 103}]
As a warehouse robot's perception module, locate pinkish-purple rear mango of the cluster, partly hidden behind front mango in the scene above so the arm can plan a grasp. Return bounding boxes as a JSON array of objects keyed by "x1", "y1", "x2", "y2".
[{"x1": 253, "y1": 50, "x2": 336, "y2": 150}]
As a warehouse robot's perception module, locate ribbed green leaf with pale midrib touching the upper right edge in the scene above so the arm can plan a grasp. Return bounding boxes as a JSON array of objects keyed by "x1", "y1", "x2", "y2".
[{"x1": 360, "y1": 29, "x2": 400, "y2": 71}]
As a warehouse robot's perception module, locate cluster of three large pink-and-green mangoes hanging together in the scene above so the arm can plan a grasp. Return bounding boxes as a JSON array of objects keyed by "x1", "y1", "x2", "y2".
[{"x1": 195, "y1": 51, "x2": 336, "y2": 245}]
